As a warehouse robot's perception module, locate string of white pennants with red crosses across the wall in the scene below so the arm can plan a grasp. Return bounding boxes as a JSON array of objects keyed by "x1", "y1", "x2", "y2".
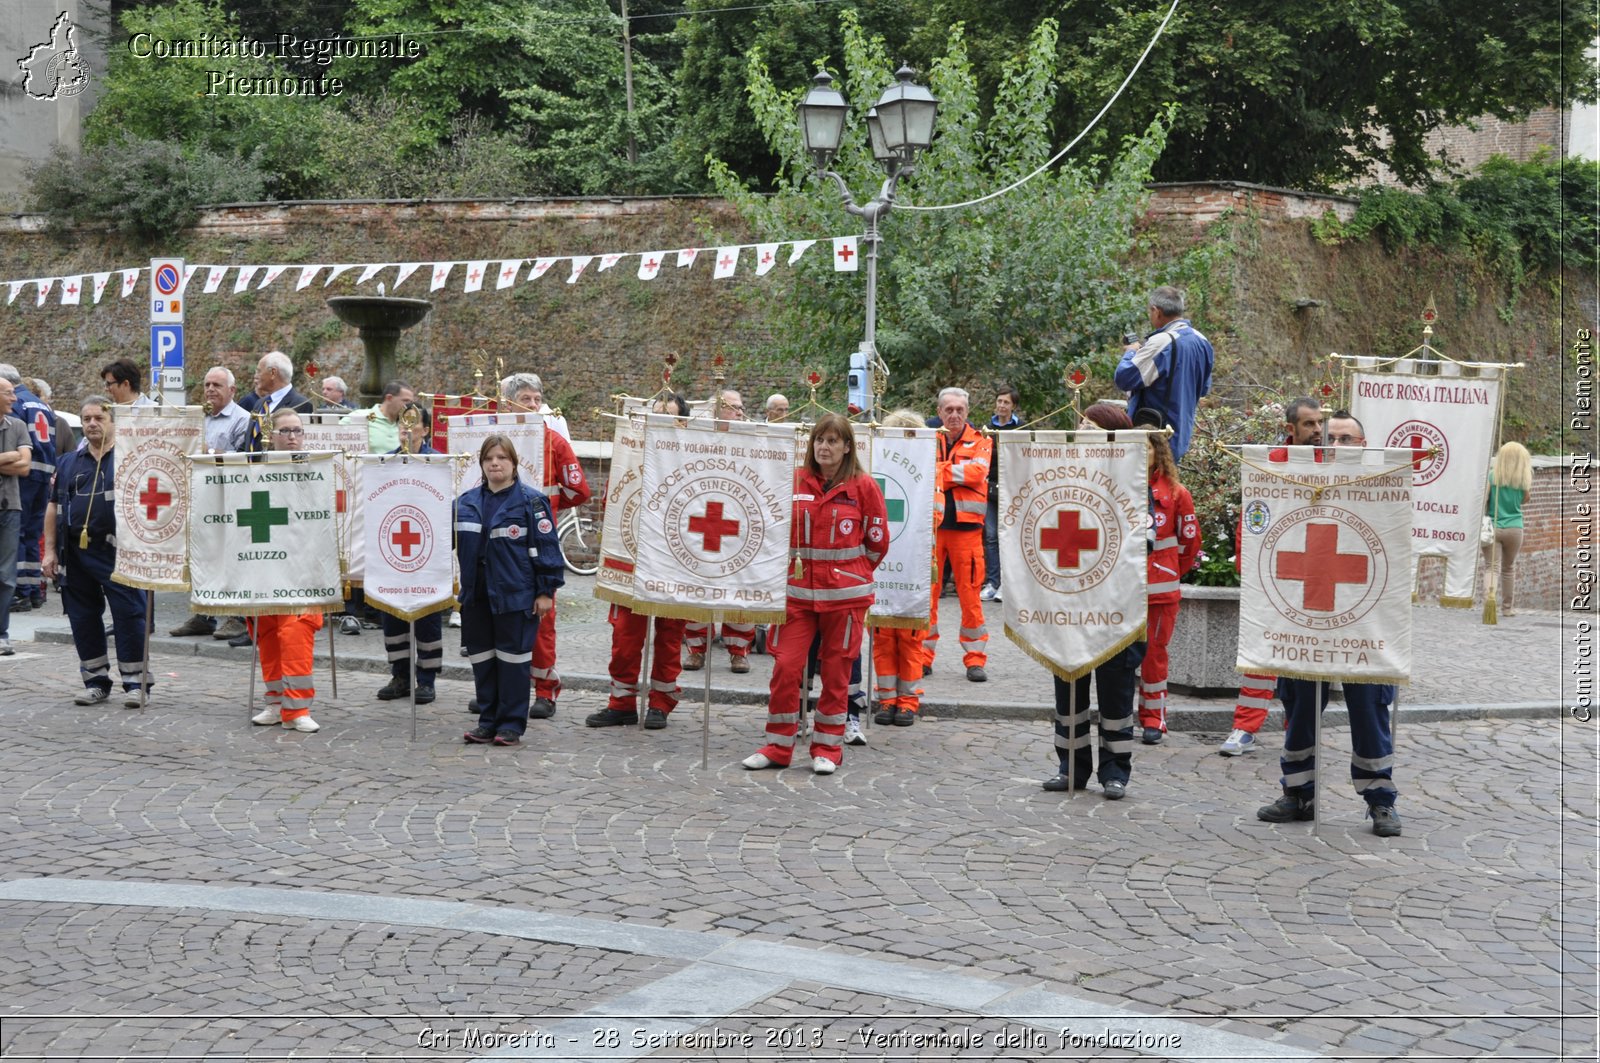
[{"x1": 0, "y1": 228, "x2": 859, "y2": 306}]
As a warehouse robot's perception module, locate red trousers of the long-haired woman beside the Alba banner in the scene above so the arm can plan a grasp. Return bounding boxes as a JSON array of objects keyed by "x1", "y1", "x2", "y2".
[{"x1": 757, "y1": 599, "x2": 867, "y2": 765}]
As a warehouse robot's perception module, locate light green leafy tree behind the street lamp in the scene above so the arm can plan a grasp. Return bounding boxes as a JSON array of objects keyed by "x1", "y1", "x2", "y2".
[{"x1": 710, "y1": 10, "x2": 1165, "y2": 410}]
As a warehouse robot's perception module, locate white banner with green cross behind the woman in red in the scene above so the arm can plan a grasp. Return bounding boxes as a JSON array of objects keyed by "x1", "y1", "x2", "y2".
[{"x1": 859, "y1": 427, "x2": 938, "y2": 628}]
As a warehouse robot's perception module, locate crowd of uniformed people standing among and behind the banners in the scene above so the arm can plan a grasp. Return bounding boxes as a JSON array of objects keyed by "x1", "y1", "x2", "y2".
[{"x1": 0, "y1": 287, "x2": 1531, "y2": 836}]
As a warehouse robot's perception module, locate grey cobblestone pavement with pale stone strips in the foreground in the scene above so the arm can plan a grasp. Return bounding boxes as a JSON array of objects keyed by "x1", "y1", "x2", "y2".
[{"x1": 0, "y1": 624, "x2": 1600, "y2": 1060}]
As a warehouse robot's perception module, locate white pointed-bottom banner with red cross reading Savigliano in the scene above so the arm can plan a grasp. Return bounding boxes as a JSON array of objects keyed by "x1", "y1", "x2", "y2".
[{"x1": 995, "y1": 431, "x2": 1150, "y2": 680}]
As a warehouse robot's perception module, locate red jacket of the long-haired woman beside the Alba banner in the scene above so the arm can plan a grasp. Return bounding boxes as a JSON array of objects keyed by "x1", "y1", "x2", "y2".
[{"x1": 789, "y1": 469, "x2": 890, "y2": 613}]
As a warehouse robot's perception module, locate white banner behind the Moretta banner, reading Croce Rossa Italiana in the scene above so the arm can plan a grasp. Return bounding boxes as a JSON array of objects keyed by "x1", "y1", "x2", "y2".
[{"x1": 1350, "y1": 359, "x2": 1504, "y2": 608}]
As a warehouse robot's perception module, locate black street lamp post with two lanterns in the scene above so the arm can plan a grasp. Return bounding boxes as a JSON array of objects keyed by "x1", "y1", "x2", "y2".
[{"x1": 800, "y1": 66, "x2": 939, "y2": 416}]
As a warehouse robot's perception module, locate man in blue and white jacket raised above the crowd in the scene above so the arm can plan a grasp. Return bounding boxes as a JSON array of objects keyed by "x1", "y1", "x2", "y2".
[{"x1": 1115, "y1": 285, "x2": 1214, "y2": 461}]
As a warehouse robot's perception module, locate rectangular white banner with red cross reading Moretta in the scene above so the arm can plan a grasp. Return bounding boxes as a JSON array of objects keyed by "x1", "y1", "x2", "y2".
[{"x1": 1235, "y1": 447, "x2": 1411, "y2": 684}]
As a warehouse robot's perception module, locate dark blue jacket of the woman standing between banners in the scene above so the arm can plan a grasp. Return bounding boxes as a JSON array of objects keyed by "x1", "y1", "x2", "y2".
[{"x1": 456, "y1": 480, "x2": 565, "y2": 613}]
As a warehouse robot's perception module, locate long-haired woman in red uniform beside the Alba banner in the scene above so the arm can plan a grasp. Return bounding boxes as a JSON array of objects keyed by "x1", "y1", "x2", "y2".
[{"x1": 744, "y1": 413, "x2": 890, "y2": 775}]
